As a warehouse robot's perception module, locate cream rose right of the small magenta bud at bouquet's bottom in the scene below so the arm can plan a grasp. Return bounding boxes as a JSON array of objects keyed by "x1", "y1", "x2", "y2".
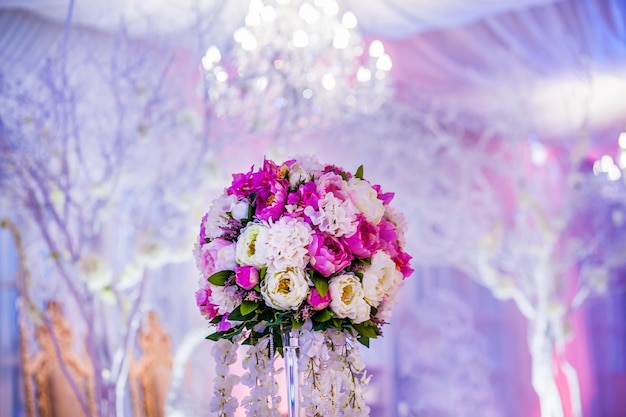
[{"x1": 328, "y1": 274, "x2": 370, "y2": 324}]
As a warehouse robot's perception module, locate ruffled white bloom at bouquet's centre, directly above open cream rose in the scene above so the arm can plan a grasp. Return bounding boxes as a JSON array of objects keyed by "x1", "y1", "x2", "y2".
[{"x1": 266, "y1": 217, "x2": 312, "y2": 271}]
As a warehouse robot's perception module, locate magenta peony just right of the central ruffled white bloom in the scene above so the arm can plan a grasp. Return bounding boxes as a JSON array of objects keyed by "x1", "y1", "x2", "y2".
[{"x1": 308, "y1": 232, "x2": 354, "y2": 277}]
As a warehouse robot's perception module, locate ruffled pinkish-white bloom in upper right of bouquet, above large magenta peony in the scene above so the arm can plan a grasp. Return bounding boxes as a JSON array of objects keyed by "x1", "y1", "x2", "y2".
[{"x1": 304, "y1": 192, "x2": 359, "y2": 237}]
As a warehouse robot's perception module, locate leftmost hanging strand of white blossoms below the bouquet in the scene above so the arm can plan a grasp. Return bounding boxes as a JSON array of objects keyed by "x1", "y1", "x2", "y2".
[{"x1": 209, "y1": 339, "x2": 239, "y2": 417}]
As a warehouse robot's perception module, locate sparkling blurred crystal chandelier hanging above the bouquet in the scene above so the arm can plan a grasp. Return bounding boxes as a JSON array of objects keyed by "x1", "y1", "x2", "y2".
[{"x1": 202, "y1": 0, "x2": 392, "y2": 131}]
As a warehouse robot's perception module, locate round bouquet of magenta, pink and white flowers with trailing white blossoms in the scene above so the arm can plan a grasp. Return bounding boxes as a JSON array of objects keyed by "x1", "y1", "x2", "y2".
[{"x1": 194, "y1": 157, "x2": 412, "y2": 415}]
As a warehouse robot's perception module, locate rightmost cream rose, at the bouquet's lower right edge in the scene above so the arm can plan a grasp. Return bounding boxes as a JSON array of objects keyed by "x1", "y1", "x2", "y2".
[{"x1": 363, "y1": 251, "x2": 402, "y2": 307}]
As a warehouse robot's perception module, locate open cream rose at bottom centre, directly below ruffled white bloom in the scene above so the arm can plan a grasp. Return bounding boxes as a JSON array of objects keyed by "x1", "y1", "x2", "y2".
[{"x1": 261, "y1": 268, "x2": 309, "y2": 310}]
